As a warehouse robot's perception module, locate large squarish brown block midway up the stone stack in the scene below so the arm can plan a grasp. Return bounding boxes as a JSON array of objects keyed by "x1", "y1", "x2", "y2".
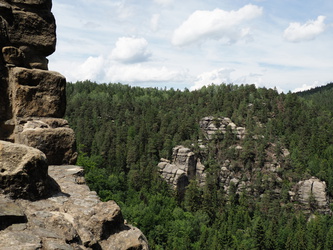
[{"x1": 9, "y1": 67, "x2": 66, "y2": 118}]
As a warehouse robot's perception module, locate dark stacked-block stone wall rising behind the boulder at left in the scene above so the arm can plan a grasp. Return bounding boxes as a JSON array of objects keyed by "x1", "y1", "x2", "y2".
[{"x1": 0, "y1": 0, "x2": 77, "y2": 164}]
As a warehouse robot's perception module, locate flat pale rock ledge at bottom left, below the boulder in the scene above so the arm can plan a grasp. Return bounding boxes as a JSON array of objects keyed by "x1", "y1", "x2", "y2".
[{"x1": 0, "y1": 165, "x2": 149, "y2": 250}]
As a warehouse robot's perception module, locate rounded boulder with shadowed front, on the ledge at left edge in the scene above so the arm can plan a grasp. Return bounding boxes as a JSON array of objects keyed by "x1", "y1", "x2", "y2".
[{"x1": 0, "y1": 141, "x2": 59, "y2": 200}]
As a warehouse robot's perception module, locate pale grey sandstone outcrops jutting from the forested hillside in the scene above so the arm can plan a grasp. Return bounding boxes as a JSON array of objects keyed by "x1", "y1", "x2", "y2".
[{"x1": 158, "y1": 117, "x2": 331, "y2": 214}]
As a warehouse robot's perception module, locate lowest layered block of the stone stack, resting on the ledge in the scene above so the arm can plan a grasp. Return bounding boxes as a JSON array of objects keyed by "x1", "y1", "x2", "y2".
[{"x1": 15, "y1": 118, "x2": 77, "y2": 165}]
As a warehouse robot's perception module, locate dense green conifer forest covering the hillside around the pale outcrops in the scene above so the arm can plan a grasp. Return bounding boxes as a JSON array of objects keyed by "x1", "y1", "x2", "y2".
[{"x1": 66, "y1": 81, "x2": 333, "y2": 249}]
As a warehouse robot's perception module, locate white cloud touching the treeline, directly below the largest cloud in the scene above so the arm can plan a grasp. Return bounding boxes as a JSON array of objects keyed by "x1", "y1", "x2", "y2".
[{"x1": 191, "y1": 68, "x2": 234, "y2": 90}]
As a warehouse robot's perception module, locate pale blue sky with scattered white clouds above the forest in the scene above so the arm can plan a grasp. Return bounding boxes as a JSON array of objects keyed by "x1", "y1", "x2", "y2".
[{"x1": 48, "y1": 0, "x2": 333, "y2": 92}]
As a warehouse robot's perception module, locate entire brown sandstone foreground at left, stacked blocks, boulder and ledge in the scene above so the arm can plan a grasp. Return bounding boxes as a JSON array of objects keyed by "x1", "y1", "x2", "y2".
[{"x1": 0, "y1": 0, "x2": 148, "y2": 250}]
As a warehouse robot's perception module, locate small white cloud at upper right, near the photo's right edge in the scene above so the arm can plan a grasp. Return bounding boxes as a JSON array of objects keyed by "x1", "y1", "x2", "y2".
[{"x1": 283, "y1": 16, "x2": 326, "y2": 42}]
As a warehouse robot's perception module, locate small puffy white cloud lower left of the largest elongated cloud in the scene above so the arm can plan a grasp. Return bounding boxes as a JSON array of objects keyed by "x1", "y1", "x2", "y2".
[{"x1": 111, "y1": 37, "x2": 151, "y2": 63}]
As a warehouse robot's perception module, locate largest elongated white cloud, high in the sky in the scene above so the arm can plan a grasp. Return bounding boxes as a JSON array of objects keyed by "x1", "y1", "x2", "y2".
[{"x1": 172, "y1": 4, "x2": 263, "y2": 46}]
